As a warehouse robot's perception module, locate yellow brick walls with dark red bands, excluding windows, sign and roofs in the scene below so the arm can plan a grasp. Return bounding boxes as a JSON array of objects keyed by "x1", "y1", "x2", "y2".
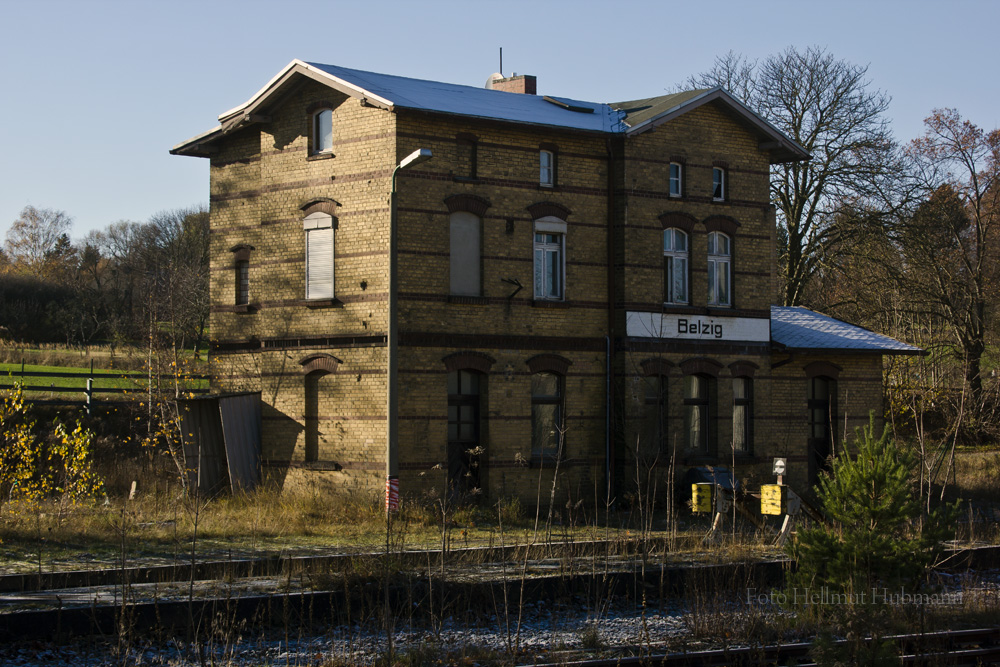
[{"x1": 176, "y1": 65, "x2": 904, "y2": 503}]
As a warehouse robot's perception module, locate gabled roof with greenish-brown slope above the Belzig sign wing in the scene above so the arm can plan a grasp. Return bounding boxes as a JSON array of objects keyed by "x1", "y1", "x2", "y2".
[{"x1": 611, "y1": 87, "x2": 810, "y2": 164}]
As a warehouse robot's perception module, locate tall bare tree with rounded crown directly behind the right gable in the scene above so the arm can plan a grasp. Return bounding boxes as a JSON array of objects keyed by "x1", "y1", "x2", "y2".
[{"x1": 686, "y1": 47, "x2": 901, "y2": 305}]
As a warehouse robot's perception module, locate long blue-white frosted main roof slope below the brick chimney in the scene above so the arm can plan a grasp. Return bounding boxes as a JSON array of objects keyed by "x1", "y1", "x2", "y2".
[{"x1": 308, "y1": 63, "x2": 625, "y2": 132}]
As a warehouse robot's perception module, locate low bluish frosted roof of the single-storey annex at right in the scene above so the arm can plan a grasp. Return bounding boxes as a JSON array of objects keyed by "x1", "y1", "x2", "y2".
[{"x1": 771, "y1": 306, "x2": 923, "y2": 354}]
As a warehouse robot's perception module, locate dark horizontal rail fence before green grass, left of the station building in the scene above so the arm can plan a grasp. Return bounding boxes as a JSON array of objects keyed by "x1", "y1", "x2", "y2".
[{"x1": 0, "y1": 361, "x2": 210, "y2": 414}]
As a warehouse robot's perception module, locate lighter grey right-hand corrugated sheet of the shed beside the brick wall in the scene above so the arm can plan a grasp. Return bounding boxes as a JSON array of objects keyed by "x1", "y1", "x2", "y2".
[{"x1": 219, "y1": 393, "x2": 260, "y2": 491}]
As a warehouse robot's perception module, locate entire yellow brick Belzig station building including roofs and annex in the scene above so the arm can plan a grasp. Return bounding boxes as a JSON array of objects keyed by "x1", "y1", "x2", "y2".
[{"x1": 171, "y1": 60, "x2": 919, "y2": 504}]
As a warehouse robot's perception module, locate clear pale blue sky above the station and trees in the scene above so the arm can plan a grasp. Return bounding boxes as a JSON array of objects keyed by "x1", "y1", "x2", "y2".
[{"x1": 0, "y1": 0, "x2": 1000, "y2": 238}]
